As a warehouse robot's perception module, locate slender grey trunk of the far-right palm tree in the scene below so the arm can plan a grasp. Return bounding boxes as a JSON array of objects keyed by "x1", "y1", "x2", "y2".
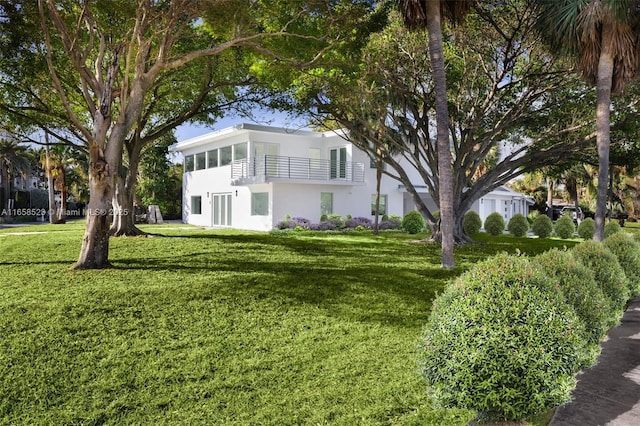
[{"x1": 593, "y1": 22, "x2": 613, "y2": 241}]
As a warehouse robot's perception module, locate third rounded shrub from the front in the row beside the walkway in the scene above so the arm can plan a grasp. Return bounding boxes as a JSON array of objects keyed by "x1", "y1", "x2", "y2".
[{"x1": 572, "y1": 240, "x2": 629, "y2": 314}]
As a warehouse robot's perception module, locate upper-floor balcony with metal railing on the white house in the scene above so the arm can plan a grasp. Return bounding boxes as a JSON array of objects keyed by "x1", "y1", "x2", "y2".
[{"x1": 231, "y1": 155, "x2": 364, "y2": 185}]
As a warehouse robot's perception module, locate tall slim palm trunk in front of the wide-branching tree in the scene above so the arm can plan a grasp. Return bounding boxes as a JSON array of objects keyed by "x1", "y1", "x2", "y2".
[{"x1": 425, "y1": 1, "x2": 454, "y2": 269}]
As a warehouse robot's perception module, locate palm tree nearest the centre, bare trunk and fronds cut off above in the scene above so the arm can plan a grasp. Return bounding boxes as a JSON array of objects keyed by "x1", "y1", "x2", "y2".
[{"x1": 398, "y1": 0, "x2": 475, "y2": 269}]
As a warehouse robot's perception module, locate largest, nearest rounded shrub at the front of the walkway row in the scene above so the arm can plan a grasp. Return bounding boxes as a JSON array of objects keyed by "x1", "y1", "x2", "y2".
[{"x1": 421, "y1": 254, "x2": 584, "y2": 420}]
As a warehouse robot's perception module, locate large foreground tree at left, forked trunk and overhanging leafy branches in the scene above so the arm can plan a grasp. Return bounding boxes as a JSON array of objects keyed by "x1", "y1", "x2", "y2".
[{"x1": 31, "y1": 0, "x2": 370, "y2": 268}]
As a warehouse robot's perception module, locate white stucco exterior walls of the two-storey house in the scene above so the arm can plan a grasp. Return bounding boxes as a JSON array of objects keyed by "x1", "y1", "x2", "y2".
[{"x1": 172, "y1": 124, "x2": 528, "y2": 231}]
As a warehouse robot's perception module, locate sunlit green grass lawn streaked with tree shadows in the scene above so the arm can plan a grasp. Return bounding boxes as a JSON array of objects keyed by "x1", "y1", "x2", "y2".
[{"x1": 0, "y1": 223, "x2": 574, "y2": 425}]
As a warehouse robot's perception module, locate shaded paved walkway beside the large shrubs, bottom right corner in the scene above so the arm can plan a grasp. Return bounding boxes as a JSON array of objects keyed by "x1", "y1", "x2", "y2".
[{"x1": 549, "y1": 296, "x2": 640, "y2": 426}]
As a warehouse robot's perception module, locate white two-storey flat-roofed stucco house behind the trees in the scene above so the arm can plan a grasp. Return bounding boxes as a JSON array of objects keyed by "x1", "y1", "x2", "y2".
[{"x1": 171, "y1": 124, "x2": 530, "y2": 231}]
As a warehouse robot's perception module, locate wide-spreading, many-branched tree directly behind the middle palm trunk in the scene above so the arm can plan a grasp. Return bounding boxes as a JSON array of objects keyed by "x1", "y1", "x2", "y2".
[{"x1": 299, "y1": 0, "x2": 624, "y2": 243}]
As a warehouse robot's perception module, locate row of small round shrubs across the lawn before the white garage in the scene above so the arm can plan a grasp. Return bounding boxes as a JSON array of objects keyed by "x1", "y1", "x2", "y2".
[{"x1": 463, "y1": 210, "x2": 622, "y2": 240}]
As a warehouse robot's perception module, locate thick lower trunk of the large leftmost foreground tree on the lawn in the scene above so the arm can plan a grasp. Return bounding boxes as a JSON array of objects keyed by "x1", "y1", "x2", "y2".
[{"x1": 75, "y1": 142, "x2": 113, "y2": 269}]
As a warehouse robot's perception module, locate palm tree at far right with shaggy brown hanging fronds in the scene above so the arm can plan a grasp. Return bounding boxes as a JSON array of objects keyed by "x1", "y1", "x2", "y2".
[{"x1": 530, "y1": 0, "x2": 640, "y2": 241}]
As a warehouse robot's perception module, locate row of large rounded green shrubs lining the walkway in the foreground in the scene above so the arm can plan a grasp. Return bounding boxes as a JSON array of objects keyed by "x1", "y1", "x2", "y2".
[{"x1": 421, "y1": 230, "x2": 640, "y2": 422}]
